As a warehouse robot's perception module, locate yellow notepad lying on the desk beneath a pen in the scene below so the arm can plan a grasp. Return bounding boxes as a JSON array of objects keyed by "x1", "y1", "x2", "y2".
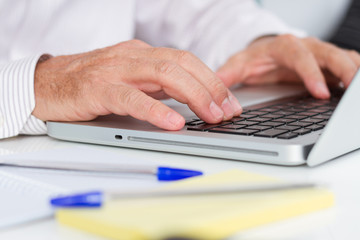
[{"x1": 56, "y1": 170, "x2": 334, "y2": 239}]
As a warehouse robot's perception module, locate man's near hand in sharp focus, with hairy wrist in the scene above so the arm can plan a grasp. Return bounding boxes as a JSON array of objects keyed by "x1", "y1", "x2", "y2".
[{"x1": 33, "y1": 40, "x2": 242, "y2": 130}]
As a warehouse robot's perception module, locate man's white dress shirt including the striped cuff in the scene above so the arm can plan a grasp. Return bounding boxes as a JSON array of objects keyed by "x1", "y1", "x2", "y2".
[{"x1": 0, "y1": 0, "x2": 298, "y2": 138}]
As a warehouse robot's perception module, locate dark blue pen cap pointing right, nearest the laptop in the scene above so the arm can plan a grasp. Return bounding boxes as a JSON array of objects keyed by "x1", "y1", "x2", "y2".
[{"x1": 157, "y1": 167, "x2": 202, "y2": 181}]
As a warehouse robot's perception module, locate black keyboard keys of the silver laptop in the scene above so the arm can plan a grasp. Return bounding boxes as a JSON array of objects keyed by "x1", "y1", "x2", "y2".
[{"x1": 186, "y1": 96, "x2": 340, "y2": 139}]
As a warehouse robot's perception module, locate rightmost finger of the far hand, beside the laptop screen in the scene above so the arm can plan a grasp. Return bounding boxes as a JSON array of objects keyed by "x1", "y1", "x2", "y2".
[{"x1": 305, "y1": 39, "x2": 358, "y2": 87}]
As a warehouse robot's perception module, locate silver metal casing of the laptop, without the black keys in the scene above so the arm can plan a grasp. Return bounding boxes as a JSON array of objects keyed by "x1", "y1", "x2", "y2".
[{"x1": 47, "y1": 72, "x2": 360, "y2": 166}]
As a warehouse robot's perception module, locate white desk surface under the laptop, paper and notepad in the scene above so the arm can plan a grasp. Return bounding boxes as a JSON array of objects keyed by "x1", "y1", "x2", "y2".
[{"x1": 0, "y1": 136, "x2": 360, "y2": 240}]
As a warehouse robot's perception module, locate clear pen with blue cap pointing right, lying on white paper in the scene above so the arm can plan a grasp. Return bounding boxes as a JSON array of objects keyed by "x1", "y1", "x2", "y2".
[{"x1": 0, "y1": 159, "x2": 202, "y2": 181}]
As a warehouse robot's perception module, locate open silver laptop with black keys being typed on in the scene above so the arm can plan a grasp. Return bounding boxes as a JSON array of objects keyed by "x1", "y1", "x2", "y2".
[{"x1": 47, "y1": 71, "x2": 360, "y2": 166}]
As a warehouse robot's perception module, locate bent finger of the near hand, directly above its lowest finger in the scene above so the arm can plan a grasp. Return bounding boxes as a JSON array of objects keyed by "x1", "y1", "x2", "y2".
[{"x1": 116, "y1": 58, "x2": 224, "y2": 123}]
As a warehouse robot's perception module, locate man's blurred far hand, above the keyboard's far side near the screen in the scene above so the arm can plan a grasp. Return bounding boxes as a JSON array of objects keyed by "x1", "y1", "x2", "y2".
[{"x1": 217, "y1": 35, "x2": 360, "y2": 99}]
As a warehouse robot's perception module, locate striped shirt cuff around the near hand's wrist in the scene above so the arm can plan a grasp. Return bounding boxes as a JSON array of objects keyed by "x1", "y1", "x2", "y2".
[{"x1": 0, "y1": 55, "x2": 46, "y2": 139}]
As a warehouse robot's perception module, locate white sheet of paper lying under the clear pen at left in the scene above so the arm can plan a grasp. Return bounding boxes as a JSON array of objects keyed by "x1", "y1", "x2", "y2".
[{"x1": 0, "y1": 145, "x2": 166, "y2": 228}]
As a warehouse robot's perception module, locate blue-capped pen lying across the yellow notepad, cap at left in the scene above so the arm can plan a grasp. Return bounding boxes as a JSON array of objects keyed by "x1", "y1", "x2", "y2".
[{"x1": 50, "y1": 182, "x2": 316, "y2": 208}]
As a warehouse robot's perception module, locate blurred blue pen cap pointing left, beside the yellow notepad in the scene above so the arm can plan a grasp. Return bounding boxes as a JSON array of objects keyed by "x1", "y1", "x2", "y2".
[{"x1": 50, "y1": 191, "x2": 103, "y2": 207}]
